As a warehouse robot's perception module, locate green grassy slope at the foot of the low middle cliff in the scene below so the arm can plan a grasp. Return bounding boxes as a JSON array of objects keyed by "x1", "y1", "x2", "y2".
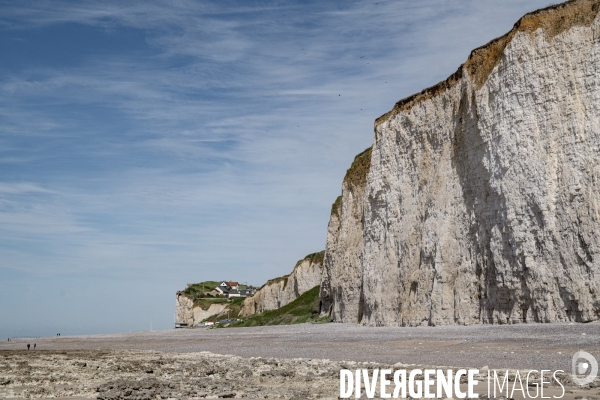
[{"x1": 230, "y1": 286, "x2": 331, "y2": 327}]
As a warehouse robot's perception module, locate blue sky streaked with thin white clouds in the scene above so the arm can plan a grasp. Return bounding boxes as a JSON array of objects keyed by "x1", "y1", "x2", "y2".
[{"x1": 0, "y1": 0, "x2": 549, "y2": 337}]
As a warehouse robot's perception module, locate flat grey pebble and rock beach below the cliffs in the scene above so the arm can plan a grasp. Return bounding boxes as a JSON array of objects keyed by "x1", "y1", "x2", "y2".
[{"x1": 0, "y1": 323, "x2": 600, "y2": 400}]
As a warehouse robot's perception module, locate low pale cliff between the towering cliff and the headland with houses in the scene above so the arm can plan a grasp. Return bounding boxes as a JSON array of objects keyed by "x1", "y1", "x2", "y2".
[{"x1": 239, "y1": 252, "x2": 323, "y2": 316}]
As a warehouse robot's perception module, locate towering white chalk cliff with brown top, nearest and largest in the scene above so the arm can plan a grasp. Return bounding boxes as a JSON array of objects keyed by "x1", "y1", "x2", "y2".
[{"x1": 322, "y1": 0, "x2": 600, "y2": 325}]
